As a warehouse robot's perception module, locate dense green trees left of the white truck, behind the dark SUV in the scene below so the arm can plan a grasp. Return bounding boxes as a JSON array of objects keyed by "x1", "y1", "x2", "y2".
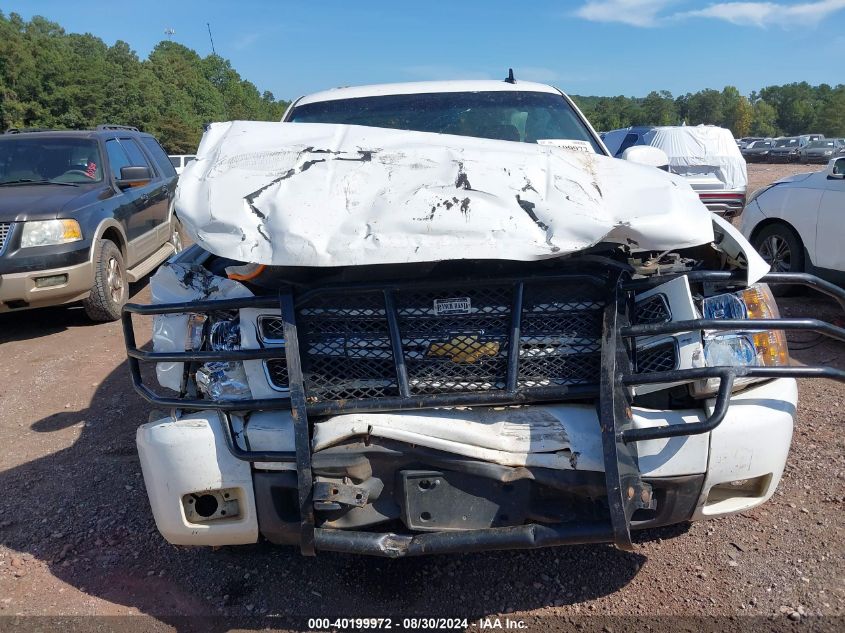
[{"x1": 0, "y1": 12, "x2": 288, "y2": 154}]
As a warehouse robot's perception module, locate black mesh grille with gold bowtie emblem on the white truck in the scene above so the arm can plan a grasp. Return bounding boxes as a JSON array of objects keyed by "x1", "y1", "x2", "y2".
[{"x1": 260, "y1": 282, "x2": 606, "y2": 402}]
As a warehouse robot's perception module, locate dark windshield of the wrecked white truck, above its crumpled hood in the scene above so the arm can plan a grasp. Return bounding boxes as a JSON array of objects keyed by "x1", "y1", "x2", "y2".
[{"x1": 288, "y1": 90, "x2": 602, "y2": 153}]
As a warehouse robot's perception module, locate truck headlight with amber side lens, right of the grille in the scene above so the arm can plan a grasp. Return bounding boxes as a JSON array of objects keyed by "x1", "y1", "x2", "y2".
[{"x1": 703, "y1": 284, "x2": 789, "y2": 367}]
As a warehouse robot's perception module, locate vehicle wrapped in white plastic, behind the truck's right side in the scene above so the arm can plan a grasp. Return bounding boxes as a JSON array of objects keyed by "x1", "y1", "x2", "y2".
[{"x1": 604, "y1": 125, "x2": 748, "y2": 218}]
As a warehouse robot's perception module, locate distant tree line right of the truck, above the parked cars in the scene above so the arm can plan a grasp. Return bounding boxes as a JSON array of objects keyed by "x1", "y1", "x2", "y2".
[{"x1": 573, "y1": 82, "x2": 845, "y2": 138}]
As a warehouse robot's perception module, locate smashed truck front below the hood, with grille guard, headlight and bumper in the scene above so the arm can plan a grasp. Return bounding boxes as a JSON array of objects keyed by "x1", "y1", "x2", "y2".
[{"x1": 124, "y1": 247, "x2": 845, "y2": 556}]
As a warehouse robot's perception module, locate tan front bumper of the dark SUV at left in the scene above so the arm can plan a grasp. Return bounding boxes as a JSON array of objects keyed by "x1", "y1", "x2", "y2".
[{"x1": 0, "y1": 261, "x2": 94, "y2": 312}]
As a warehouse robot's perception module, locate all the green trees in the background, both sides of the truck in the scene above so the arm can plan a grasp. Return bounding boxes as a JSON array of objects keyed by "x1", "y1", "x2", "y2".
[{"x1": 0, "y1": 12, "x2": 845, "y2": 154}]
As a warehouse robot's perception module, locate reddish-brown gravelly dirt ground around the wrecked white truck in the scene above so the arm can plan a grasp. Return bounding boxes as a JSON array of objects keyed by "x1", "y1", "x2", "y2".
[{"x1": 0, "y1": 165, "x2": 845, "y2": 630}]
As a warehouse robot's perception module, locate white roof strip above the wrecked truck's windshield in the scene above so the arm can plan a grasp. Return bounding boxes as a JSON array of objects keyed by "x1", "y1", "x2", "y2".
[{"x1": 294, "y1": 79, "x2": 561, "y2": 105}]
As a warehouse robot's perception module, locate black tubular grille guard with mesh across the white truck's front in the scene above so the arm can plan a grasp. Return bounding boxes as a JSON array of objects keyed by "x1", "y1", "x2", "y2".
[{"x1": 122, "y1": 271, "x2": 845, "y2": 557}]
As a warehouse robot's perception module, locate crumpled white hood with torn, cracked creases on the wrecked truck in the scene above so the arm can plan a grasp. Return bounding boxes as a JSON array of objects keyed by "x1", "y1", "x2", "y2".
[{"x1": 176, "y1": 121, "x2": 713, "y2": 266}]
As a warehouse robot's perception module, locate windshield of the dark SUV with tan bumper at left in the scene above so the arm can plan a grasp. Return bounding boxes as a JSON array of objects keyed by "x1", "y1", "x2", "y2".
[{"x1": 0, "y1": 136, "x2": 103, "y2": 184}]
